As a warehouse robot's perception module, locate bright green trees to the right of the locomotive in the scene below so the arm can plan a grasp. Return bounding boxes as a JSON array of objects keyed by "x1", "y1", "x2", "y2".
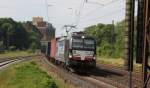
[{"x1": 84, "y1": 21, "x2": 125, "y2": 58}]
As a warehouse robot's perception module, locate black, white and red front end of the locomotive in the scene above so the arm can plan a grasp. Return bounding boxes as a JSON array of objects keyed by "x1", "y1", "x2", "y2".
[{"x1": 69, "y1": 36, "x2": 96, "y2": 67}]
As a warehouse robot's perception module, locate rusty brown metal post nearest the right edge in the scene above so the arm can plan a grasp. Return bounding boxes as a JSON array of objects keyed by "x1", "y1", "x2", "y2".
[{"x1": 142, "y1": 0, "x2": 150, "y2": 88}]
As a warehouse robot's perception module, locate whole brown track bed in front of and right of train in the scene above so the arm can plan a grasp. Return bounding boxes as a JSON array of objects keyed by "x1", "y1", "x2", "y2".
[{"x1": 44, "y1": 55, "x2": 150, "y2": 88}]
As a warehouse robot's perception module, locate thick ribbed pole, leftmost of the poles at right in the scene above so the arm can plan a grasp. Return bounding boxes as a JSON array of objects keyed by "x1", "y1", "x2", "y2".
[{"x1": 124, "y1": 0, "x2": 135, "y2": 88}]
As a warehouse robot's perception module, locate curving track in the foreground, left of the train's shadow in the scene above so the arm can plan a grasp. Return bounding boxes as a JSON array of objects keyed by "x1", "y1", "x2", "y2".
[{"x1": 43, "y1": 58, "x2": 117, "y2": 88}]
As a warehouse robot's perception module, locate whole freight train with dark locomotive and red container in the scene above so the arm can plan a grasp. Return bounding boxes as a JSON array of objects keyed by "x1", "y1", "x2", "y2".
[{"x1": 41, "y1": 32, "x2": 96, "y2": 71}]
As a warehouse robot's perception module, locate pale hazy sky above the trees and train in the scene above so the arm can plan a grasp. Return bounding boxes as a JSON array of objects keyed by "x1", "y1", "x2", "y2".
[{"x1": 0, "y1": 0, "x2": 129, "y2": 36}]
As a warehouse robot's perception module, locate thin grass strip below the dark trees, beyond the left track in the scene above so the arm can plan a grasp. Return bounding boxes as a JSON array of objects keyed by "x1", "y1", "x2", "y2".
[{"x1": 0, "y1": 51, "x2": 34, "y2": 58}]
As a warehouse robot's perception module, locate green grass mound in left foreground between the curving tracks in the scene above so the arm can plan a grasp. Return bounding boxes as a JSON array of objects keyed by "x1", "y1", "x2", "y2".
[{"x1": 0, "y1": 61, "x2": 58, "y2": 88}]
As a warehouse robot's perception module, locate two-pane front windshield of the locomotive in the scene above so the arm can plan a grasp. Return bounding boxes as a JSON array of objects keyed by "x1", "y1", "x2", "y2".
[{"x1": 72, "y1": 38, "x2": 95, "y2": 49}]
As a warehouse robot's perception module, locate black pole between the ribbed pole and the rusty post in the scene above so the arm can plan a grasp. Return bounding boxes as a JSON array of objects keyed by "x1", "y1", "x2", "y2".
[{"x1": 136, "y1": 0, "x2": 144, "y2": 64}]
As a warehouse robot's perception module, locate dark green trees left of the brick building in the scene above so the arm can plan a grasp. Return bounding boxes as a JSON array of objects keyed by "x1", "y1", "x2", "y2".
[{"x1": 0, "y1": 18, "x2": 53, "y2": 50}]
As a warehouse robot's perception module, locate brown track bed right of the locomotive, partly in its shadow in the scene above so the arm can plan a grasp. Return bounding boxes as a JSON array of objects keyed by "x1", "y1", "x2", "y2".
[{"x1": 87, "y1": 68, "x2": 141, "y2": 88}]
